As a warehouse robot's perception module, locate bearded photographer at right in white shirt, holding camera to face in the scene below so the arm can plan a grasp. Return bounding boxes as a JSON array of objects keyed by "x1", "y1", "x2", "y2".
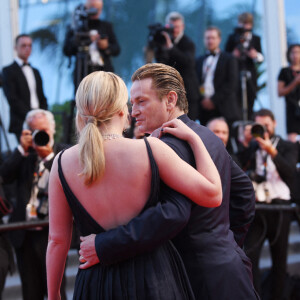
[{"x1": 238, "y1": 109, "x2": 297, "y2": 300}]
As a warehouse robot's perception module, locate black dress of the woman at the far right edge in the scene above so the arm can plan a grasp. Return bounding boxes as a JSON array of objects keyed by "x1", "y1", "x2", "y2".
[{"x1": 278, "y1": 67, "x2": 300, "y2": 134}]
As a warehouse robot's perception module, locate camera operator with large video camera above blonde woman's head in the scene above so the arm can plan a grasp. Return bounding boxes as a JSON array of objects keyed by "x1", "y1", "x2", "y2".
[{"x1": 63, "y1": 0, "x2": 121, "y2": 89}]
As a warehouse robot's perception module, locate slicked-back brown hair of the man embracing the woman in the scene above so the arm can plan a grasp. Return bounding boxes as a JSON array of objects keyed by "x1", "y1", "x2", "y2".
[{"x1": 131, "y1": 63, "x2": 188, "y2": 113}]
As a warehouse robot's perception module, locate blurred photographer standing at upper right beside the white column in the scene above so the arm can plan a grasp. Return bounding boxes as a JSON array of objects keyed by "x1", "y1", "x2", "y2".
[{"x1": 225, "y1": 12, "x2": 264, "y2": 120}]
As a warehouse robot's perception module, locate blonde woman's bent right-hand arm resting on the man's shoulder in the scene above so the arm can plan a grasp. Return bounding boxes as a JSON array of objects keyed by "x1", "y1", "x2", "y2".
[{"x1": 149, "y1": 119, "x2": 222, "y2": 207}]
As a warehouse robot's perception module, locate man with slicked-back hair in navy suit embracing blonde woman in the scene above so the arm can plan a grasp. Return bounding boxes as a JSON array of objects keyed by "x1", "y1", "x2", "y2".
[{"x1": 79, "y1": 64, "x2": 257, "y2": 300}]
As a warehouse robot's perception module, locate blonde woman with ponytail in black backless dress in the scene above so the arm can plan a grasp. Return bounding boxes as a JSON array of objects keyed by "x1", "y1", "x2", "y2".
[{"x1": 47, "y1": 72, "x2": 222, "y2": 300}]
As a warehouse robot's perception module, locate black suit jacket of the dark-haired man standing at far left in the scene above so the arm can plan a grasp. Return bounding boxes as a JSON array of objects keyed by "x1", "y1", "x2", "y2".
[{"x1": 3, "y1": 62, "x2": 48, "y2": 134}]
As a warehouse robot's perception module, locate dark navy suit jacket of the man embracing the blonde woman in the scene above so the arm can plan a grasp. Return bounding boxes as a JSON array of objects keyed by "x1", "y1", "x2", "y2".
[{"x1": 95, "y1": 115, "x2": 256, "y2": 300}]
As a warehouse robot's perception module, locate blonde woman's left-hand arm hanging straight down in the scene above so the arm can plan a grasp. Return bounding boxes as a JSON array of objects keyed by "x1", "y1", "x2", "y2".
[{"x1": 46, "y1": 158, "x2": 73, "y2": 300}]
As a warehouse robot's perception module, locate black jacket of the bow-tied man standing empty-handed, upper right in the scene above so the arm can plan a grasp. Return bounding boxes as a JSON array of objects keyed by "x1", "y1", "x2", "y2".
[{"x1": 196, "y1": 52, "x2": 241, "y2": 125}]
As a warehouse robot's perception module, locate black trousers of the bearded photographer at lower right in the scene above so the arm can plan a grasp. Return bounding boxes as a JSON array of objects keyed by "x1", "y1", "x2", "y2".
[{"x1": 244, "y1": 204, "x2": 292, "y2": 300}]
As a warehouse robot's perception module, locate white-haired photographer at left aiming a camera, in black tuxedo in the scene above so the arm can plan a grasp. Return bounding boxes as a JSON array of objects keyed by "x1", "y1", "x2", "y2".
[{"x1": 0, "y1": 109, "x2": 66, "y2": 300}]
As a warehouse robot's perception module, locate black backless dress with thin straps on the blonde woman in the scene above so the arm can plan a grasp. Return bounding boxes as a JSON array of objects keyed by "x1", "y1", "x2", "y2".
[{"x1": 58, "y1": 139, "x2": 195, "y2": 300}]
